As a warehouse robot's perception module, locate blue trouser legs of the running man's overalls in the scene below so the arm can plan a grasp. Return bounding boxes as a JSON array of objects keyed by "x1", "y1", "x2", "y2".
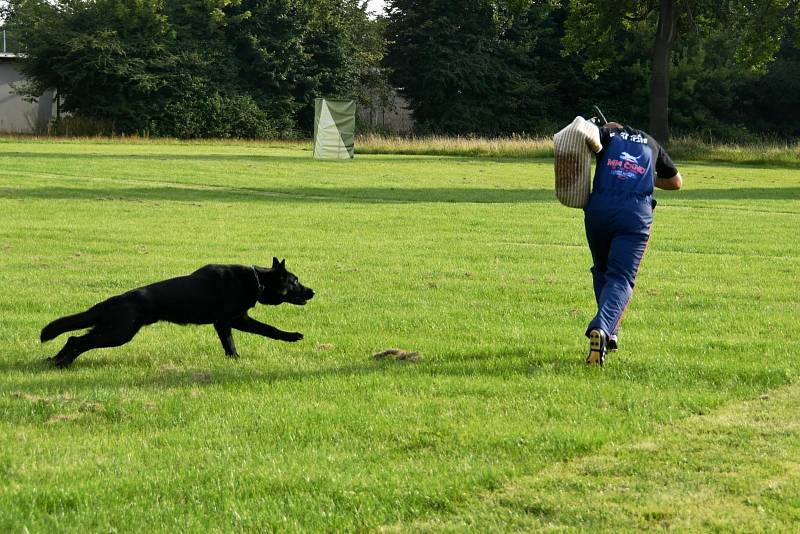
[{"x1": 584, "y1": 193, "x2": 655, "y2": 336}]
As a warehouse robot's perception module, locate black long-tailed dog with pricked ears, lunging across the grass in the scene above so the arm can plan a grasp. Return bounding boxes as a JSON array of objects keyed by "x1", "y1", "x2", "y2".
[{"x1": 41, "y1": 258, "x2": 314, "y2": 367}]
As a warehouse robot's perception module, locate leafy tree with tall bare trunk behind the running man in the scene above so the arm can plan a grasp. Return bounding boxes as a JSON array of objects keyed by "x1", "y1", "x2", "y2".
[{"x1": 564, "y1": 0, "x2": 799, "y2": 142}]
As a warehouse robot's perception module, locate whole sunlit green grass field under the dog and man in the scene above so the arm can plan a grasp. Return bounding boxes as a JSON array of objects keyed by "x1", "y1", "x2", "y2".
[{"x1": 0, "y1": 140, "x2": 800, "y2": 532}]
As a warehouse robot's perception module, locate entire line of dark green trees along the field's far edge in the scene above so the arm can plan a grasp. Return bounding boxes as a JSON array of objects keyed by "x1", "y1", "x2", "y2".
[{"x1": 4, "y1": 0, "x2": 800, "y2": 140}]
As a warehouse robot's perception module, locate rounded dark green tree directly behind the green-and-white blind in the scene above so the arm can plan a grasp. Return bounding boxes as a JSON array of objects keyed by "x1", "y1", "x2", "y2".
[{"x1": 219, "y1": 0, "x2": 383, "y2": 133}]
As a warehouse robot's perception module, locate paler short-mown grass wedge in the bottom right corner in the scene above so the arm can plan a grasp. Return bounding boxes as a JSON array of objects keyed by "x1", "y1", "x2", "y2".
[{"x1": 422, "y1": 384, "x2": 800, "y2": 532}]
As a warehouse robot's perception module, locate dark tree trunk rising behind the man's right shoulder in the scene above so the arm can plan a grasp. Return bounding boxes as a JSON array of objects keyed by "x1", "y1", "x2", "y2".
[{"x1": 650, "y1": 0, "x2": 679, "y2": 143}]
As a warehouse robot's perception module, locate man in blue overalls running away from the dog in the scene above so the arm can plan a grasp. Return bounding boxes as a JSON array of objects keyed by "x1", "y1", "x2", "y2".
[{"x1": 584, "y1": 122, "x2": 683, "y2": 365}]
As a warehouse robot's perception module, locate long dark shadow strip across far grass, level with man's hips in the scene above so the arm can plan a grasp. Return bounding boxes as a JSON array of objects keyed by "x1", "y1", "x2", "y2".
[{"x1": 6, "y1": 185, "x2": 800, "y2": 204}]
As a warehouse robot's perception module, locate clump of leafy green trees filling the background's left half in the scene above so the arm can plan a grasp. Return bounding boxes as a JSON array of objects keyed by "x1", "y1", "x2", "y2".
[{"x1": 5, "y1": 0, "x2": 381, "y2": 137}]
